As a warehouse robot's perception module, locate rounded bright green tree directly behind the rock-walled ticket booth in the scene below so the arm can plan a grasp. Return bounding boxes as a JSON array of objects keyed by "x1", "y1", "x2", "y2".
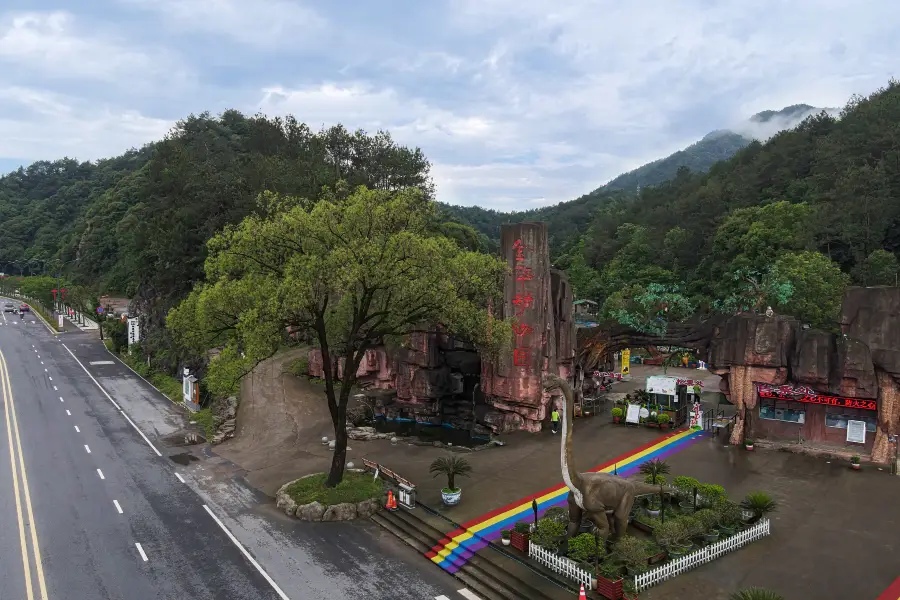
[{"x1": 772, "y1": 251, "x2": 850, "y2": 330}]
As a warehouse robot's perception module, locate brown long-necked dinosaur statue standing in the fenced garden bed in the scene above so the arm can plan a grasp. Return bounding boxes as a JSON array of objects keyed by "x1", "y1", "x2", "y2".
[{"x1": 544, "y1": 373, "x2": 664, "y2": 540}]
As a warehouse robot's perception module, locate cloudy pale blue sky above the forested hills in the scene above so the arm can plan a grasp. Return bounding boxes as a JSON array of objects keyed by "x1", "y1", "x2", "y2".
[{"x1": 0, "y1": 0, "x2": 900, "y2": 211}]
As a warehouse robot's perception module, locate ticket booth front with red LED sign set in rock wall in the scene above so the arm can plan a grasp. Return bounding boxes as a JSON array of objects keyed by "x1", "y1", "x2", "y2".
[{"x1": 754, "y1": 383, "x2": 878, "y2": 452}]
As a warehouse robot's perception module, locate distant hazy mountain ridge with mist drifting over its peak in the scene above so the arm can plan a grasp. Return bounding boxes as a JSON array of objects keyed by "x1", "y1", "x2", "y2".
[{"x1": 445, "y1": 104, "x2": 833, "y2": 257}]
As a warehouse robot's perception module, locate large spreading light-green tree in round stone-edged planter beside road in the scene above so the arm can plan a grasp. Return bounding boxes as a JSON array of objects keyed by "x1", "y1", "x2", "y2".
[{"x1": 168, "y1": 186, "x2": 511, "y2": 486}]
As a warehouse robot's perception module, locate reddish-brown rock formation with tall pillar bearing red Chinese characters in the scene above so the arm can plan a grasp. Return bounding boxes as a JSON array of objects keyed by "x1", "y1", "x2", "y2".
[{"x1": 309, "y1": 223, "x2": 575, "y2": 433}]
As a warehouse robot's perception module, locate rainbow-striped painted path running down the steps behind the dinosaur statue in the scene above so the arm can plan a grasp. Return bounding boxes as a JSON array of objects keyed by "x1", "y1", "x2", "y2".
[{"x1": 425, "y1": 429, "x2": 707, "y2": 573}]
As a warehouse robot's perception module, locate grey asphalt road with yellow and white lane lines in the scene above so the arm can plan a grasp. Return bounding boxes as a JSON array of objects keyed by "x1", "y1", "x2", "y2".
[{"x1": 0, "y1": 300, "x2": 474, "y2": 600}]
